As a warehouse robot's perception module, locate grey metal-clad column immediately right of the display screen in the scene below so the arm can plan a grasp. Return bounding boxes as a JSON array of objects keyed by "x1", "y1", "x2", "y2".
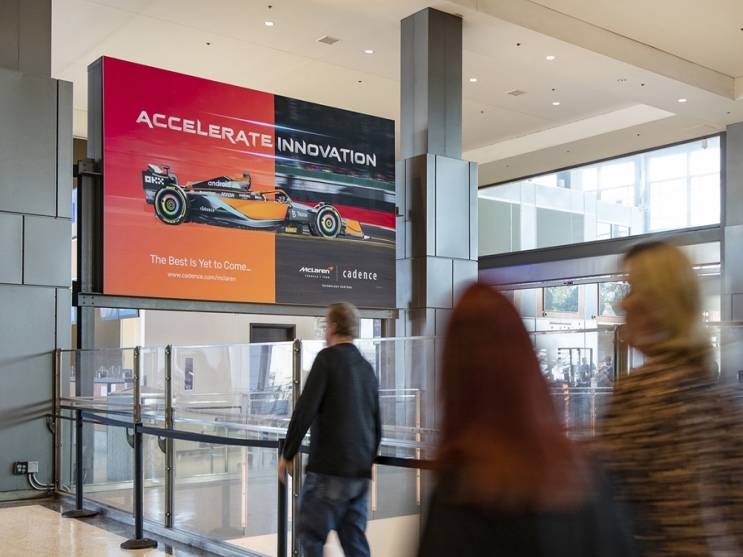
[{"x1": 396, "y1": 8, "x2": 477, "y2": 336}]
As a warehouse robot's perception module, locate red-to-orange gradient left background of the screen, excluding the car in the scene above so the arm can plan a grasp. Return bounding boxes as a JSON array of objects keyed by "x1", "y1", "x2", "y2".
[{"x1": 103, "y1": 58, "x2": 275, "y2": 302}]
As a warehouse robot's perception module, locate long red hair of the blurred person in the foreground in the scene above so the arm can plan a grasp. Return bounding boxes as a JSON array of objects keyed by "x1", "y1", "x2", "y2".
[{"x1": 437, "y1": 284, "x2": 588, "y2": 510}]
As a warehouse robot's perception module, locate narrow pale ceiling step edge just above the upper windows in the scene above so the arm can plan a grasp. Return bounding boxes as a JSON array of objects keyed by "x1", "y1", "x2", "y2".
[{"x1": 462, "y1": 104, "x2": 675, "y2": 164}]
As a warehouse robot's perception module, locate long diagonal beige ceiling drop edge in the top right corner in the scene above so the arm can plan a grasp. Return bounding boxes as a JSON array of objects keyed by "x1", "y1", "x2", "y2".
[{"x1": 454, "y1": 0, "x2": 743, "y2": 100}]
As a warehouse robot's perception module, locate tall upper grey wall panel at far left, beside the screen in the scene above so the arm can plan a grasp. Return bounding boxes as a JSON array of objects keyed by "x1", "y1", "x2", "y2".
[{"x1": 0, "y1": 69, "x2": 57, "y2": 216}]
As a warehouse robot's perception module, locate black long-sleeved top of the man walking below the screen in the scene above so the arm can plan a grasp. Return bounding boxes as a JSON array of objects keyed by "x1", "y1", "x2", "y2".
[{"x1": 284, "y1": 342, "x2": 382, "y2": 478}]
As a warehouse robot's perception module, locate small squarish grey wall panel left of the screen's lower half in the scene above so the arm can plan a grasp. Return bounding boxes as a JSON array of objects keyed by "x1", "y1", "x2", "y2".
[{"x1": 23, "y1": 216, "x2": 72, "y2": 287}]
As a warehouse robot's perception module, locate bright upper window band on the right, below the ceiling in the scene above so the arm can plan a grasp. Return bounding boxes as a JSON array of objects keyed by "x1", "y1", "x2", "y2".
[{"x1": 478, "y1": 136, "x2": 720, "y2": 256}]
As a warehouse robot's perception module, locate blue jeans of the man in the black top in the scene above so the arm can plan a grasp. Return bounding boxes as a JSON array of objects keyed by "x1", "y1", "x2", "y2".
[{"x1": 297, "y1": 472, "x2": 371, "y2": 557}]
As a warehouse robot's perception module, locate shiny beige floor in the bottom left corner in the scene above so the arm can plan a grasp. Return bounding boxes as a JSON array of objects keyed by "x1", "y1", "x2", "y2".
[{"x1": 0, "y1": 499, "x2": 222, "y2": 557}]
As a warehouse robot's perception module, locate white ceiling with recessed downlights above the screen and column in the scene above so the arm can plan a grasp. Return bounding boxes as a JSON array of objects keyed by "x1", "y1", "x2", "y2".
[{"x1": 52, "y1": 0, "x2": 743, "y2": 164}]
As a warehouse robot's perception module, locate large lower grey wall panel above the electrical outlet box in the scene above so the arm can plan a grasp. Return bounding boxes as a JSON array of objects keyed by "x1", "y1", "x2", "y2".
[{"x1": 0, "y1": 285, "x2": 55, "y2": 491}]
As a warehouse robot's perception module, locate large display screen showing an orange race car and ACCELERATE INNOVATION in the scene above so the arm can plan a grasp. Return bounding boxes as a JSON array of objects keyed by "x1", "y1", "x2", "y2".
[{"x1": 96, "y1": 58, "x2": 395, "y2": 308}]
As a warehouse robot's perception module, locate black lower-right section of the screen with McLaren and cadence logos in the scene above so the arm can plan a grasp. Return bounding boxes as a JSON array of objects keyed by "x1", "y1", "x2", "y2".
[{"x1": 276, "y1": 232, "x2": 396, "y2": 308}]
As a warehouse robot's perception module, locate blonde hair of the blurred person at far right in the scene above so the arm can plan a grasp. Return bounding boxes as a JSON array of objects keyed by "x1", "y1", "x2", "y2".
[{"x1": 624, "y1": 242, "x2": 710, "y2": 353}]
